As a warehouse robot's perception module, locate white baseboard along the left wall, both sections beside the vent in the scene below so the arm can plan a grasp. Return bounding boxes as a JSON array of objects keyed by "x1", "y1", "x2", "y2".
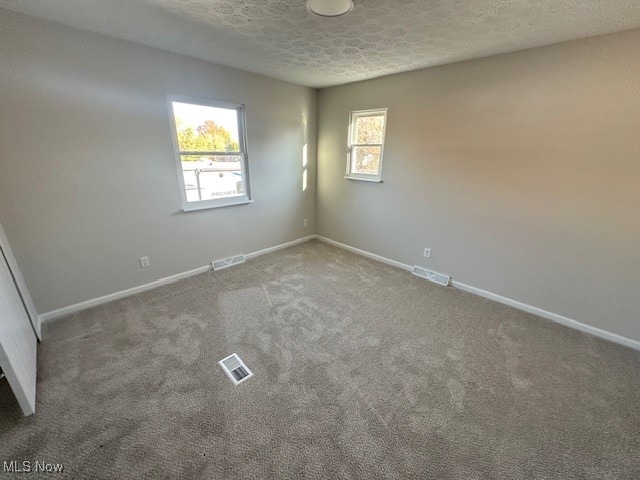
[{"x1": 38, "y1": 235, "x2": 316, "y2": 325}]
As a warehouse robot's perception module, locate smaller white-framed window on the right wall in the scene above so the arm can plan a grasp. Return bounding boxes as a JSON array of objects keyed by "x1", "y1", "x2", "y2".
[{"x1": 346, "y1": 108, "x2": 387, "y2": 182}]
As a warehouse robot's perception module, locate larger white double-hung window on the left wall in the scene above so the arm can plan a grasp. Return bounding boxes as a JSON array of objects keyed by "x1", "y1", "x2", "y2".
[{"x1": 170, "y1": 97, "x2": 251, "y2": 211}]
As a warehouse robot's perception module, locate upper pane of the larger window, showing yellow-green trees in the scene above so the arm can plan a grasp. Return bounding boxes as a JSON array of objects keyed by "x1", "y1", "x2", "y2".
[{"x1": 172, "y1": 102, "x2": 240, "y2": 152}]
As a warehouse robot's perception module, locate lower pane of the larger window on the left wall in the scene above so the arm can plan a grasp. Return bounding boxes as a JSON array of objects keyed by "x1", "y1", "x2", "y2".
[{"x1": 181, "y1": 155, "x2": 245, "y2": 202}]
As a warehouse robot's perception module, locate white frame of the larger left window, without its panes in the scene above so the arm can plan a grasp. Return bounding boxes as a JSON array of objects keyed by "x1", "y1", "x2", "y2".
[{"x1": 167, "y1": 95, "x2": 253, "y2": 212}]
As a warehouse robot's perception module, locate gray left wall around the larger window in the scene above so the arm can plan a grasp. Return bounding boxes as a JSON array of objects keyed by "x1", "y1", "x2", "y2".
[{"x1": 0, "y1": 10, "x2": 317, "y2": 313}]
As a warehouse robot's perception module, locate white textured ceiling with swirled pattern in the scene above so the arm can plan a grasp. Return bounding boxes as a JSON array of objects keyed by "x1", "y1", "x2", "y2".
[{"x1": 0, "y1": 0, "x2": 640, "y2": 87}]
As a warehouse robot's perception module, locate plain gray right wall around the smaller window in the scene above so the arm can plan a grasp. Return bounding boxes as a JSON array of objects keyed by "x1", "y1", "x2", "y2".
[{"x1": 318, "y1": 30, "x2": 640, "y2": 340}]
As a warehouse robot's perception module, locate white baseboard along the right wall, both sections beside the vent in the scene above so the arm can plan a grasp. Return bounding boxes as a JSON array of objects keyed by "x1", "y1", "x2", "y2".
[{"x1": 316, "y1": 235, "x2": 640, "y2": 351}]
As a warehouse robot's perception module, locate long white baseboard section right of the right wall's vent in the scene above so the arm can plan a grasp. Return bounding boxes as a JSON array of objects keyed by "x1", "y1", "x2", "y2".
[{"x1": 451, "y1": 280, "x2": 640, "y2": 350}]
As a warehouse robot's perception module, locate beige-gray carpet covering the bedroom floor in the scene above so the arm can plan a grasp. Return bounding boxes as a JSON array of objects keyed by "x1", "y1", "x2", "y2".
[{"x1": 0, "y1": 242, "x2": 640, "y2": 479}]
